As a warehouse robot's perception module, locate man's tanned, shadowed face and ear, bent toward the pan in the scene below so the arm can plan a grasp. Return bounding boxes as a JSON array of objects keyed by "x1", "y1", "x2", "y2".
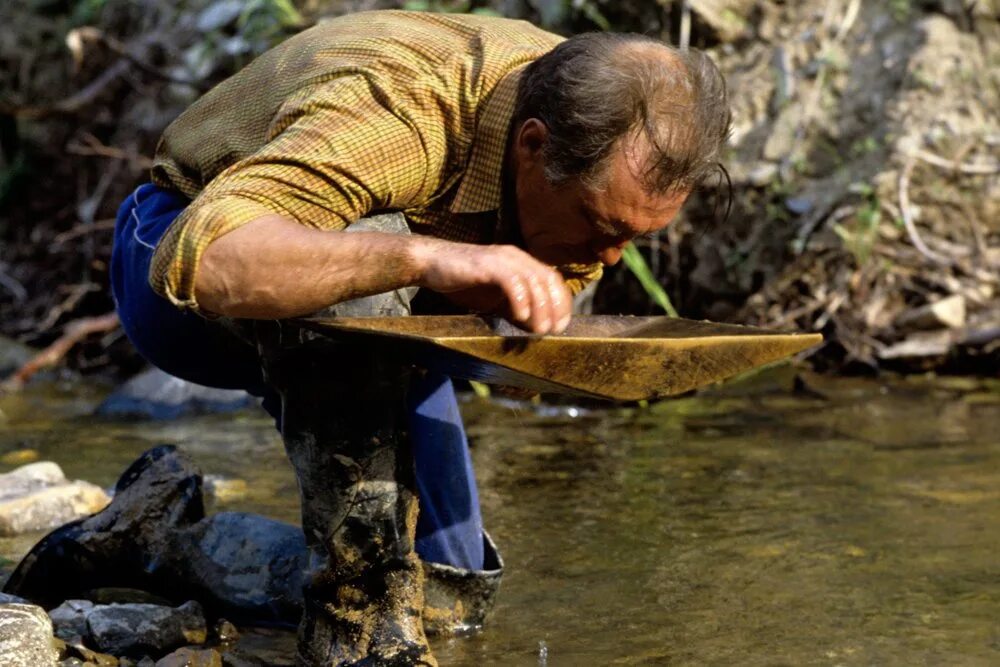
[{"x1": 514, "y1": 120, "x2": 688, "y2": 266}]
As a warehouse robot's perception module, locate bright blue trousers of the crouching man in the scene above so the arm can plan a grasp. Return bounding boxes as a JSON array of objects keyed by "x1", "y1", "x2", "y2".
[{"x1": 111, "y1": 184, "x2": 483, "y2": 570}]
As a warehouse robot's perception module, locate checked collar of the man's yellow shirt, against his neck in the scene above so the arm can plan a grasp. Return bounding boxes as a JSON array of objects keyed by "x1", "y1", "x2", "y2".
[{"x1": 450, "y1": 63, "x2": 527, "y2": 213}]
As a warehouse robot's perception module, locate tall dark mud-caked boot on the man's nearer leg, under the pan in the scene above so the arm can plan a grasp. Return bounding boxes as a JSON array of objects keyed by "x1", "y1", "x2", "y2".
[{"x1": 258, "y1": 332, "x2": 437, "y2": 667}]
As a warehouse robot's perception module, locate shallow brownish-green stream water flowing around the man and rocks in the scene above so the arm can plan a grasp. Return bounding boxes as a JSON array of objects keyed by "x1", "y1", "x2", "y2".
[{"x1": 0, "y1": 369, "x2": 1000, "y2": 666}]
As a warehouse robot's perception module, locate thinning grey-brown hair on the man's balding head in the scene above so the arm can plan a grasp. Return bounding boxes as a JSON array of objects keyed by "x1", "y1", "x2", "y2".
[{"x1": 514, "y1": 33, "x2": 730, "y2": 192}]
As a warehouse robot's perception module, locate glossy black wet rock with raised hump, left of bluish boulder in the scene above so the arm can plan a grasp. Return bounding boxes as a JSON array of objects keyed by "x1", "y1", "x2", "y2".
[{"x1": 4, "y1": 445, "x2": 205, "y2": 608}]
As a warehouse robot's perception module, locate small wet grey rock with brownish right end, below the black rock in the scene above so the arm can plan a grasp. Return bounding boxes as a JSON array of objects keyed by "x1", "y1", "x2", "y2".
[{"x1": 87, "y1": 602, "x2": 208, "y2": 656}]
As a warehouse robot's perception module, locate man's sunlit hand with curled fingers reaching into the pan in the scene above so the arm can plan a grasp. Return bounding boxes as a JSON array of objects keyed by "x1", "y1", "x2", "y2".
[{"x1": 418, "y1": 239, "x2": 573, "y2": 334}]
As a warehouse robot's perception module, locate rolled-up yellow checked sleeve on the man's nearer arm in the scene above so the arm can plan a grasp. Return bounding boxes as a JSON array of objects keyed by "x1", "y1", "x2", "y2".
[{"x1": 149, "y1": 75, "x2": 446, "y2": 311}]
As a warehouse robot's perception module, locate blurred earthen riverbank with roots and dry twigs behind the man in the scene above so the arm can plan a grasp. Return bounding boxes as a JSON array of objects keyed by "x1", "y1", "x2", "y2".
[{"x1": 0, "y1": 0, "x2": 1000, "y2": 376}]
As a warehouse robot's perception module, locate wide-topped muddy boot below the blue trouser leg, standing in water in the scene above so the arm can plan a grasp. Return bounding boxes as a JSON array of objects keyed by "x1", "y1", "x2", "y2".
[{"x1": 423, "y1": 533, "x2": 503, "y2": 636}]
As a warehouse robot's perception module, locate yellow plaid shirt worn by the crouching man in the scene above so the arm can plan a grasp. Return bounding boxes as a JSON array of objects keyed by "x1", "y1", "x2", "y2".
[{"x1": 150, "y1": 11, "x2": 600, "y2": 310}]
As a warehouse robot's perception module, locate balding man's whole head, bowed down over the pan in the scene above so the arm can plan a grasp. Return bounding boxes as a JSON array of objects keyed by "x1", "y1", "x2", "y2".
[{"x1": 509, "y1": 33, "x2": 729, "y2": 265}]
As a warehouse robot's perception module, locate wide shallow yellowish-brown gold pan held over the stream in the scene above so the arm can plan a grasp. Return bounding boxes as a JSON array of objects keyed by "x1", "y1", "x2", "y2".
[{"x1": 300, "y1": 315, "x2": 823, "y2": 401}]
